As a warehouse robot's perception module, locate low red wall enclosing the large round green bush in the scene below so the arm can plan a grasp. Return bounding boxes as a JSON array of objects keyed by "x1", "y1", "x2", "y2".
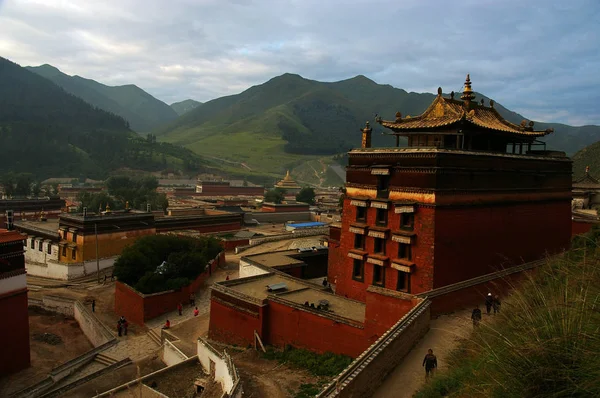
[{"x1": 115, "y1": 252, "x2": 225, "y2": 325}]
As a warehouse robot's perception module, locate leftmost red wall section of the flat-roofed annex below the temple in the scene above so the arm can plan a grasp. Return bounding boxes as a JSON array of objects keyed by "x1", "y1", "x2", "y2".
[{"x1": 208, "y1": 297, "x2": 266, "y2": 347}]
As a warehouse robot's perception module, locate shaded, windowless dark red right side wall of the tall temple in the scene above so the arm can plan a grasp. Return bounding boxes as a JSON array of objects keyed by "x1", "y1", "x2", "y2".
[{"x1": 434, "y1": 200, "x2": 571, "y2": 288}]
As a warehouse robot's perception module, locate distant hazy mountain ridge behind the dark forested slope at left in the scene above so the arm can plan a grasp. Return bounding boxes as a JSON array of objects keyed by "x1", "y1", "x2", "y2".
[{"x1": 26, "y1": 65, "x2": 178, "y2": 133}]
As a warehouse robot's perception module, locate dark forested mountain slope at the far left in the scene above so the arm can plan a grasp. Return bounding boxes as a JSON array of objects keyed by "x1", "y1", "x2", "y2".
[{"x1": 0, "y1": 57, "x2": 202, "y2": 180}]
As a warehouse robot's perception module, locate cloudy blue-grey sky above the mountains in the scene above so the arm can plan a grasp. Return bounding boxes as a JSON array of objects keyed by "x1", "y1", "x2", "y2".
[{"x1": 0, "y1": 0, "x2": 600, "y2": 125}]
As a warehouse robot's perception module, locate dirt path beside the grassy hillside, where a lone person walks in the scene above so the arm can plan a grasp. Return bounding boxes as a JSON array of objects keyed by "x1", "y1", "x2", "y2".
[{"x1": 373, "y1": 310, "x2": 473, "y2": 398}]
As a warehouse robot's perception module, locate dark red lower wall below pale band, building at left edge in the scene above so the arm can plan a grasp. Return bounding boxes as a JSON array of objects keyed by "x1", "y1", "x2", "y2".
[{"x1": 0, "y1": 289, "x2": 30, "y2": 375}]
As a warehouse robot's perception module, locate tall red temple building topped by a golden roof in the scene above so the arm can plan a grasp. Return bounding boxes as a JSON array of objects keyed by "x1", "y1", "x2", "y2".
[{"x1": 329, "y1": 75, "x2": 571, "y2": 301}]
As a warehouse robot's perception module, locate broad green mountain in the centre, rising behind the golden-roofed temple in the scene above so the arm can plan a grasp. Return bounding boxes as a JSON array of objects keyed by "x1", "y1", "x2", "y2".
[{"x1": 155, "y1": 74, "x2": 600, "y2": 178}]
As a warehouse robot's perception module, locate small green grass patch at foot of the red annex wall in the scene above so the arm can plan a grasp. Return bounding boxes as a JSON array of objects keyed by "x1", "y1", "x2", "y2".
[{"x1": 263, "y1": 346, "x2": 352, "y2": 376}]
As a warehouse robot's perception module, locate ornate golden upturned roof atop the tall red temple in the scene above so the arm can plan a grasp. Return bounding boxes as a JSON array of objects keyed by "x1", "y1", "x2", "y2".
[{"x1": 377, "y1": 75, "x2": 554, "y2": 137}]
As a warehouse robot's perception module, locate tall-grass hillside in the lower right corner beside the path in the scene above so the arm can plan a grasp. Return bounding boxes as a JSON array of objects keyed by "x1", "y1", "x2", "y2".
[{"x1": 416, "y1": 229, "x2": 600, "y2": 398}]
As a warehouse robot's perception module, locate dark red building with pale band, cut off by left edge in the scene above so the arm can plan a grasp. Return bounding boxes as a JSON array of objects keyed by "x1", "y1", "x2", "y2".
[{"x1": 0, "y1": 229, "x2": 30, "y2": 375}]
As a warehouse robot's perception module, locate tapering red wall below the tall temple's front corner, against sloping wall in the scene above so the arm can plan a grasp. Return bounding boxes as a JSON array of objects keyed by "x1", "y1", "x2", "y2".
[{"x1": 365, "y1": 291, "x2": 418, "y2": 341}]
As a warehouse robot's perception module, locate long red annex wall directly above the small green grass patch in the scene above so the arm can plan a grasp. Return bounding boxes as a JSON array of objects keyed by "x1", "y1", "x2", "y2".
[{"x1": 266, "y1": 301, "x2": 372, "y2": 357}]
